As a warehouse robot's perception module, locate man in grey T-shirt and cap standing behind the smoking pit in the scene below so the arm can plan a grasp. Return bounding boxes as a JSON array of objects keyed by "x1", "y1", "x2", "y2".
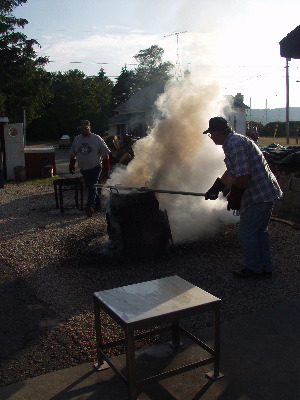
[{"x1": 69, "y1": 120, "x2": 110, "y2": 217}]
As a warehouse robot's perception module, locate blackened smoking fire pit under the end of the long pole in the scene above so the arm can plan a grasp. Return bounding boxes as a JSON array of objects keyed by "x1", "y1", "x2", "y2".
[{"x1": 106, "y1": 190, "x2": 172, "y2": 257}]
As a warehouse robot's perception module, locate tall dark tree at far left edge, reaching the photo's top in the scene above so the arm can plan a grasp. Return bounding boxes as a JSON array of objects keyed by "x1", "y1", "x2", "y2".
[{"x1": 0, "y1": 0, "x2": 51, "y2": 122}]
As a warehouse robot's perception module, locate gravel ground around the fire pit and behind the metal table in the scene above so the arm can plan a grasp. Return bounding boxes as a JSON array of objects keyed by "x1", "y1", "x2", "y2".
[{"x1": 0, "y1": 185, "x2": 300, "y2": 386}]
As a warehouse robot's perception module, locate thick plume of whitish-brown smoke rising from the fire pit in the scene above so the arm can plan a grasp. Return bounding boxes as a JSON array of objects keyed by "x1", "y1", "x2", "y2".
[{"x1": 108, "y1": 79, "x2": 237, "y2": 242}]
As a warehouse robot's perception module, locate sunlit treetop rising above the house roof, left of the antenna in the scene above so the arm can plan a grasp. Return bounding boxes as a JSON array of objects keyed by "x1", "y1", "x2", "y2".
[{"x1": 134, "y1": 45, "x2": 173, "y2": 91}]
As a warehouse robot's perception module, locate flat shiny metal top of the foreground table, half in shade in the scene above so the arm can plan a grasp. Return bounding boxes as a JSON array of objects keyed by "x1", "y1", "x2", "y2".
[{"x1": 94, "y1": 275, "x2": 221, "y2": 329}]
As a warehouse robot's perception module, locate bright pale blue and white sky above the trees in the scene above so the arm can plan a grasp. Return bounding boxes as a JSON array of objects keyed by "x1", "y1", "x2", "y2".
[{"x1": 14, "y1": 0, "x2": 300, "y2": 108}]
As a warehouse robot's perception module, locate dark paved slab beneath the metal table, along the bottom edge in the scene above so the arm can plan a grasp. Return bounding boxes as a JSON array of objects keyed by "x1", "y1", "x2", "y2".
[{"x1": 0, "y1": 299, "x2": 300, "y2": 400}]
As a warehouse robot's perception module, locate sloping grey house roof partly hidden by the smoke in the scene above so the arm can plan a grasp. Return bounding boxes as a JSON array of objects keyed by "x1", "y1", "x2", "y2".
[{"x1": 115, "y1": 83, "x2": 165, "y2": 111}]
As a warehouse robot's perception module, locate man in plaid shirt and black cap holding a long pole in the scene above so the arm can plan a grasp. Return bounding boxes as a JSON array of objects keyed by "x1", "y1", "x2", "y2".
[{"x1": 203, "y1": 117, "x2": 282, "y2": 278}]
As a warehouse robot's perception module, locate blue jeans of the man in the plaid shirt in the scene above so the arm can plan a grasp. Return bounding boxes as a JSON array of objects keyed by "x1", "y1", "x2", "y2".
[{"x1": 239, "y1": 203, "x2": 274, "y2": 273}]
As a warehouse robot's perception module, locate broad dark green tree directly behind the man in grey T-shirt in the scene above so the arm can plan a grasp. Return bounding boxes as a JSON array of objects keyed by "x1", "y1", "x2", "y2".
[{"x1": 27, "y1": 69, "x2": 113, "y2": 140}]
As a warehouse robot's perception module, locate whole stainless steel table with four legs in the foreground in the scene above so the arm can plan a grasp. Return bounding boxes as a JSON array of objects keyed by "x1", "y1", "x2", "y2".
[{"x1": 93, "y1": 275, "x2": 223, "y2": 400}]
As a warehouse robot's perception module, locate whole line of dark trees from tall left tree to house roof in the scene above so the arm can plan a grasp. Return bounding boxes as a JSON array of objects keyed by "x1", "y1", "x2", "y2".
[{"x1": 0, "y1": 0, "x2": 173, "y2": 140}]
